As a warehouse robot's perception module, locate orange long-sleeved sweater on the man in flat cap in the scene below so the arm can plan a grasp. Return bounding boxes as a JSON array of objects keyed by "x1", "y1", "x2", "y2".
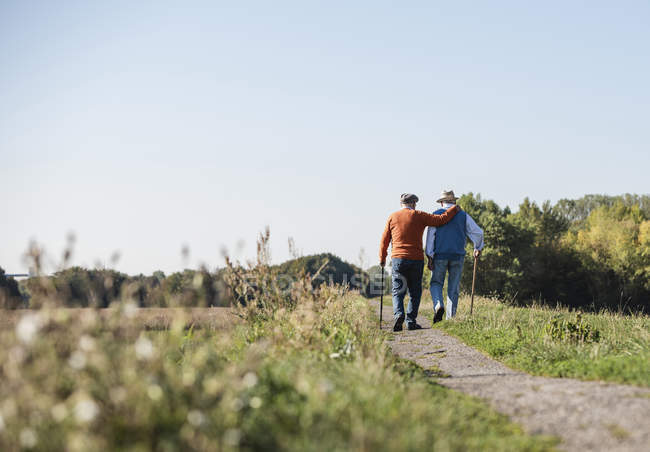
[{"x1": 379, "y1": 206, "x2": 460, "y2": 264}]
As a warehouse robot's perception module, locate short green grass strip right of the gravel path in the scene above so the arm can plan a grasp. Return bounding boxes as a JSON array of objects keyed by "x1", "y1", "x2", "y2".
[{"x1": 428, "y1": 296, "x2": 650, "y2": 386}]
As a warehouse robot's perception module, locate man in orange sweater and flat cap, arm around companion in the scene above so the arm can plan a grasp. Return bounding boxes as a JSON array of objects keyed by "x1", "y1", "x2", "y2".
[{"x1": 379, "y1": 193, "x2": 460, "y2": 331}]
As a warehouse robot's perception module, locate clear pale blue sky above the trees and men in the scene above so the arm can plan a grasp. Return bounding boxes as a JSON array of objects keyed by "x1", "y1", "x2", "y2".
[{"x1": 0, "y1": 0, "x2": 650, "y2": 273}]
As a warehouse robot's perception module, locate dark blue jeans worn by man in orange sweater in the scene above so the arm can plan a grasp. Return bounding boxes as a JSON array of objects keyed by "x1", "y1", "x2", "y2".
[{"x1": 391, "y1": 258, "x2": 424, "y2": 323}]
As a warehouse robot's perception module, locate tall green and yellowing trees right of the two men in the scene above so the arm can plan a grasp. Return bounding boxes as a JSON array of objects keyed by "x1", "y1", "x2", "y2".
[{"x1": 458, "y1": 193, "x2": 650, "y2": 312}]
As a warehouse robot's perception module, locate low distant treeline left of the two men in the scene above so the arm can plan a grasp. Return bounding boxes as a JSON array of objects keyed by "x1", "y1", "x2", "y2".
[{"x1": 0, "y1": 253, "x2": 370, "y2": 309}]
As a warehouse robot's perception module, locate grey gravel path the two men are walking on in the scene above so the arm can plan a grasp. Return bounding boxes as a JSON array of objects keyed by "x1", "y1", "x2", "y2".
[{"x1": 375, "y1": 303, "x2": 650, "y2": 452}]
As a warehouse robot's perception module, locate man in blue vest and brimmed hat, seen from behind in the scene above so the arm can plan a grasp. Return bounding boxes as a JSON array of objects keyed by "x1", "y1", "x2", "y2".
[{"x1": 425, "y1": 190, "x2": 483, "y2": 323}]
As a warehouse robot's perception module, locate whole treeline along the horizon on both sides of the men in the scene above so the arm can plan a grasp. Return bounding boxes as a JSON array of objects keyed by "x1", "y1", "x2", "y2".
[{"x1": 0, "y1": 193, "x2": 650, "y2": 312}]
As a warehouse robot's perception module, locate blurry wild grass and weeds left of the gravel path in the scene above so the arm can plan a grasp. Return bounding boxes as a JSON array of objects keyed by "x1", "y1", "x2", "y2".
[{"x1": 0, "y1": 289, "x2": 555, "y2": 451}]
